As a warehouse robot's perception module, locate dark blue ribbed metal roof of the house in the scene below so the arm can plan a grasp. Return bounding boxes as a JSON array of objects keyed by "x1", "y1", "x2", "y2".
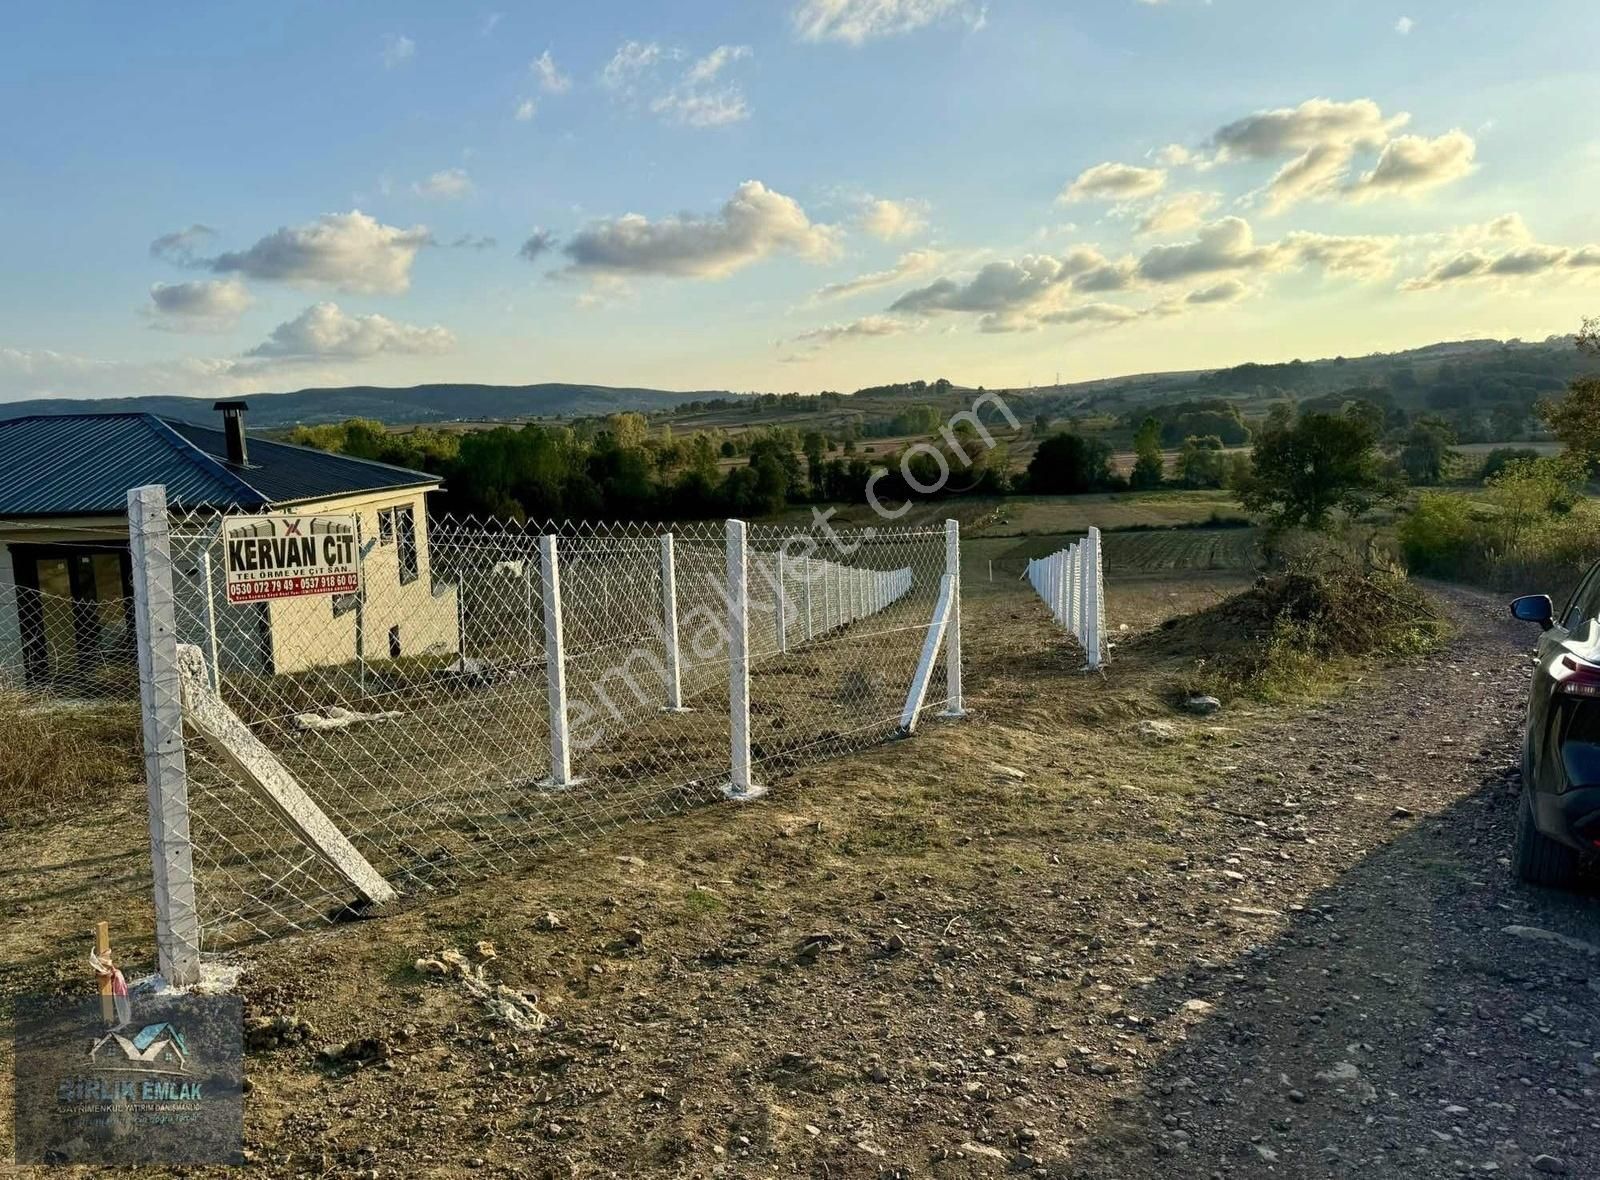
[{"x1": 0, "y1": 414, "x2": 438, "y2": 518}]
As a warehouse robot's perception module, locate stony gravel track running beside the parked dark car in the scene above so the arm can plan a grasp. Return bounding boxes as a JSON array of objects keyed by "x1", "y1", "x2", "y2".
[{"x1": 1067, "y1": 592, "x2": 1600, "y2": 1180}]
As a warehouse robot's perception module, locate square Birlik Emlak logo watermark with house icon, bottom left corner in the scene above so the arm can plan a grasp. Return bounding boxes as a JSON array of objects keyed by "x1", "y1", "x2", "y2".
[{"x1": 13, "y1": 993, "x2": 243, "y2": 1164}]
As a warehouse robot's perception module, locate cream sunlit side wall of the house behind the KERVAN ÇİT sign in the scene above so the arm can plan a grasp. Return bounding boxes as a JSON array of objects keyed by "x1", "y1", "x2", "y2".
[{"x1": 264, "y1": 489, "x2": 459, "y2": 673}]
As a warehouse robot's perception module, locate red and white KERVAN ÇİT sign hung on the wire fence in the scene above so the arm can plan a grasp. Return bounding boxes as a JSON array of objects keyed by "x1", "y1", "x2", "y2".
[{"x1": 222, "y1": 516, "x2": 362, "y2": 604}]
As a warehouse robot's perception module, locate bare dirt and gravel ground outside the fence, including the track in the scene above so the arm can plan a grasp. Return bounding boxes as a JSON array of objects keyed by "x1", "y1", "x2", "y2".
[{"x1": 0, "y1": 574, "x2": 1600, "y2": 1180}]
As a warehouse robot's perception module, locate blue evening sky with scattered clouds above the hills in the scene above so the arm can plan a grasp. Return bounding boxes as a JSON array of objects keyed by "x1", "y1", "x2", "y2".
[{"x1": 0, "y1": 0, "x2": 1600, "y2": 401}]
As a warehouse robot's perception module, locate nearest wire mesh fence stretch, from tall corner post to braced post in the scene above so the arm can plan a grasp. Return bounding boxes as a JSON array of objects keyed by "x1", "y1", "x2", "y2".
[{"x1": 121, "y1": 492, "x2": 958, "y2": 947}]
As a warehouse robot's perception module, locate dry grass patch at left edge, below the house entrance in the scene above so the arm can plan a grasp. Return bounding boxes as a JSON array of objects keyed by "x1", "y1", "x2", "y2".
[{"x1": 0, "y1": 692, "x2": 141, "y2": 828}]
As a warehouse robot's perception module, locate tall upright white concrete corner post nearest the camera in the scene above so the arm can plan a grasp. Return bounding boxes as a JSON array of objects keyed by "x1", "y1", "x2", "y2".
[{"x1": 128, "y1": 484, "x2": 200, "y2": 987}]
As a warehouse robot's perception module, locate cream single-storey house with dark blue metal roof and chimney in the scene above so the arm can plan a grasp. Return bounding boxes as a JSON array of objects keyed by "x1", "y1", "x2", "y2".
[{"x1": 0, "y1": 401, "x2": 459, "y2": 688}]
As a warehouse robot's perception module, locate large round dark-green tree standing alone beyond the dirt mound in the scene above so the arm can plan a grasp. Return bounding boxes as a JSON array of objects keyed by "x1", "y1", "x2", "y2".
[{"x1": 1240, "y1": 414, "x2": 1394, "y2": 529}]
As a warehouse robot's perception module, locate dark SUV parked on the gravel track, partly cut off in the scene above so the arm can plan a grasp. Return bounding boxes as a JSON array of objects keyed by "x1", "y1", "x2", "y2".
[{"x1": 1510, "y1": 575, "x2": 1600, "y2": 886}]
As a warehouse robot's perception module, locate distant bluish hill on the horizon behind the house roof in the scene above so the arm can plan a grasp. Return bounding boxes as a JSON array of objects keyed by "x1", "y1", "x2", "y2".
[{"x1": 0, "y1": 382, "x2": 738, "y2": 429}]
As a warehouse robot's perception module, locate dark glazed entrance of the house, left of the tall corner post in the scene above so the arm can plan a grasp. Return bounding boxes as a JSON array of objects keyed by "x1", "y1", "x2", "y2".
[{"x1": 11, "y1": 542, "x2": 134, "y2": 691}]
